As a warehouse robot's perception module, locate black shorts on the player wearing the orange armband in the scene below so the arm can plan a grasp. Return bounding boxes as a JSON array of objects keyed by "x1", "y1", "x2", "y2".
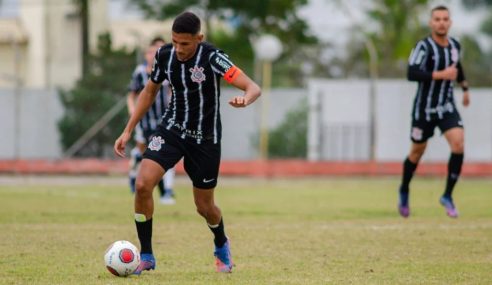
[{"x1": 143, "y1": 127, "x2": 220, "y2": 189}]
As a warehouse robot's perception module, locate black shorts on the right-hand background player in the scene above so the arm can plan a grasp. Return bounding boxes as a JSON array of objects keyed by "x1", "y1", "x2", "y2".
[{"x1": 410, "y1": 108, "x2": 463, "y2": 143}]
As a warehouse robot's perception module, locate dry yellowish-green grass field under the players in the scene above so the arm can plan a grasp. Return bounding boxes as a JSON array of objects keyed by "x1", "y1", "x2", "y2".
[{"x1": 0, "y1": 176, "x2": 492, "y2": 285}]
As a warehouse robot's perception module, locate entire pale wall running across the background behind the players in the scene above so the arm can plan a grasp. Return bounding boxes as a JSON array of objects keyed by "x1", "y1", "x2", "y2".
[{"x1": 0, "y1": 80, "x2": 492, "y2": 162}]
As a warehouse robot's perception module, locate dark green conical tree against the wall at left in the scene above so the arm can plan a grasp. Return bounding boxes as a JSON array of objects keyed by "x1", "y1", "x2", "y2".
[{"x1": 58, "y1": 35, "x2": 135, "y2": 157}]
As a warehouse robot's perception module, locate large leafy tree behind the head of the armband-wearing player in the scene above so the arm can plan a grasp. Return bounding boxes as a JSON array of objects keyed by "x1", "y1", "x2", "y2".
[{"x1": 128, "y1": 0, "x2": 317, "y2": 85}]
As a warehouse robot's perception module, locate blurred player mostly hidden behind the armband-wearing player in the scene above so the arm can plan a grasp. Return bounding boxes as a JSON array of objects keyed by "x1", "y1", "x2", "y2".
[{"x1": 127, "y1": 37, "x2": 175, "y2": 205}]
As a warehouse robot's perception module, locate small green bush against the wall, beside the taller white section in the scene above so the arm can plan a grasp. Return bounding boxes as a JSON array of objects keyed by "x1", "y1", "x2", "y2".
[{"x1": 268, "y1": 101, "x2": 308, "y2": 158}]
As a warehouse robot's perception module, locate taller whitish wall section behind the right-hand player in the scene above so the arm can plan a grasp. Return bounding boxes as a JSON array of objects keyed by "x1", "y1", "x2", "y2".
[{"x1": 308, "y1": 80, "x2": 492, "y2": 161}]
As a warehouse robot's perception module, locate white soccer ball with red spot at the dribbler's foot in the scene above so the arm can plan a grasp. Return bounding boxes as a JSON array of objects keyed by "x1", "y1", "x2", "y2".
[{"x1": 104, "y1": 240, "x2": 140, "y2": 277}]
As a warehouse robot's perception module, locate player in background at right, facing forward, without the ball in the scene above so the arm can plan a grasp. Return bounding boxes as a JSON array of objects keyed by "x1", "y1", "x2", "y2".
[{"x1": 398, "y1": 6, "x2": 470, "y2": 218}]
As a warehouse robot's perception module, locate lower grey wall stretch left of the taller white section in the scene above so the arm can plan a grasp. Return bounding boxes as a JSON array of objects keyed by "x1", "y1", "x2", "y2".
[{"x1": 0, "y1": 86, "x2": 307, "y2": 159}]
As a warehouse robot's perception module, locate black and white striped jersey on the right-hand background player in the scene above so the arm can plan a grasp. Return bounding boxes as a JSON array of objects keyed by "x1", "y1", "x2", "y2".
[{"x1": 408, "y1": 36, "x2": 465, "y2": 121}]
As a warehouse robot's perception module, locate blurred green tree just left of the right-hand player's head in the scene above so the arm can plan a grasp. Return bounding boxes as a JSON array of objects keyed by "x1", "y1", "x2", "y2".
[{"x1": 331, "y1": 0, "x2": 428, "y2": 78}]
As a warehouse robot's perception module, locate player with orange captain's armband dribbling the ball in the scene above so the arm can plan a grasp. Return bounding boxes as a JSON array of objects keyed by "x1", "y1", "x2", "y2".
[{"x1": 114, "y1": 12, "x2": 261, "y2": 274}]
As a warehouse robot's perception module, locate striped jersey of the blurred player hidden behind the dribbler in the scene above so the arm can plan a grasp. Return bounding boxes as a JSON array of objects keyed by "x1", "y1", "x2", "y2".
[{"x1": 128, "y1": 63, "x2": 169, "y2": 131}]
